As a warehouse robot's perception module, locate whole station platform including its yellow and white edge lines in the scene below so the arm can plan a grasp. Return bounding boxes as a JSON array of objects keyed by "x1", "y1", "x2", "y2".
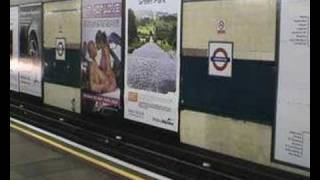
[{"x1": 10, "y1": 117, "x2": 167, "y2": 180}]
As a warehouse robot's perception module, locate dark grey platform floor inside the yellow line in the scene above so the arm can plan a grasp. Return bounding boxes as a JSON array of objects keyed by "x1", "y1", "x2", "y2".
[{"x1": 10, "y1": 129, "x2": 125, "y2": 180}]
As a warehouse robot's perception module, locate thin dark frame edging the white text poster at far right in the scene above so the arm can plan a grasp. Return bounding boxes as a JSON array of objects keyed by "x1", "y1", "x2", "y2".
[{"x1": 270, "y1": 0, "x2": 310, "y2": 172}]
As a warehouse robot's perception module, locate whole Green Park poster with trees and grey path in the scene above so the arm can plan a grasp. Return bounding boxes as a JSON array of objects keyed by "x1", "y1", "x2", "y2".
[{"x1": 124, "y1": 0, "x2": 181, "y2": 132}]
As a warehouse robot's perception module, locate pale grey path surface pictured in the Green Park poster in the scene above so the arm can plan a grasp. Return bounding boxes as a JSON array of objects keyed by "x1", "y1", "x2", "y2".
[{"x1": 127, "y1": 41, "x2": 177, "y2": 94}]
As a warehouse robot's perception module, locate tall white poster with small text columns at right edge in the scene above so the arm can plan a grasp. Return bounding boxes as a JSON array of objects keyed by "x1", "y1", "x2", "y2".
[{"x1": 274, "y1": 0, "x2": 310, "y2": 168}]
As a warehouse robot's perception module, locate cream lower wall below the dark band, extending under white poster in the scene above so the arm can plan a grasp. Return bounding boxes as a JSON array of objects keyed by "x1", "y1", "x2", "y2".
[{"x1": 180, "y1": 110, "x2": 310, "y2": 176}]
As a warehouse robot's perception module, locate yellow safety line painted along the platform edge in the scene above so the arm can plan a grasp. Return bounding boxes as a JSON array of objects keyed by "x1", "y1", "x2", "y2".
[{"x1": 10, "y1": 123, "x2": 143, "y2": 180}]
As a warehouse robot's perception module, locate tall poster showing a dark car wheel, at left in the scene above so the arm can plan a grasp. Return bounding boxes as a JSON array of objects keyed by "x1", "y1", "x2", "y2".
[{"x1": 19, "y1": 4, "x2": 42, "y2": 97}]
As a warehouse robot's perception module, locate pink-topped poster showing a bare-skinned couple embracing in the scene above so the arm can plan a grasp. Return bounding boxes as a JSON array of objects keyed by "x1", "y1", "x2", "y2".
[{"x1": 81, "y1": 0, "x2": 123, "y2": 114}]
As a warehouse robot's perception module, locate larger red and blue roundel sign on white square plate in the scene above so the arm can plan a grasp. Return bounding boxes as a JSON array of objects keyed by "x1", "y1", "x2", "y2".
[{"x1": 209, "y1": 42, "x2": 233, "y2": 77}]
